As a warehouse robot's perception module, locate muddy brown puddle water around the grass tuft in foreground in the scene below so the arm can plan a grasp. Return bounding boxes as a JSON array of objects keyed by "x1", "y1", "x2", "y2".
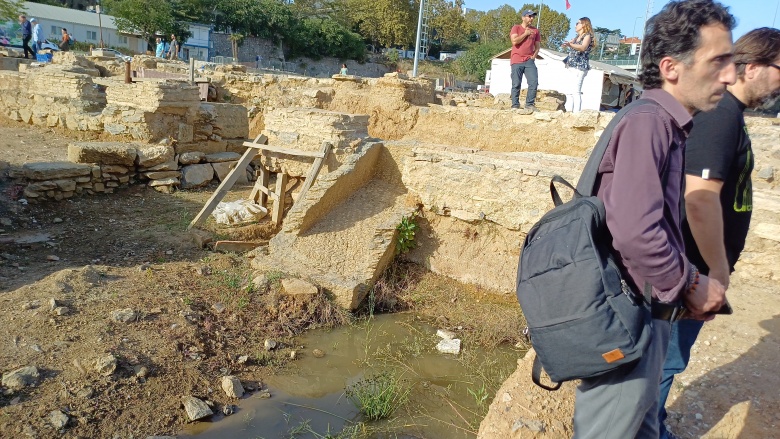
[{"x1": 185, "y1": 314, "x2": 522, "y2": 439}]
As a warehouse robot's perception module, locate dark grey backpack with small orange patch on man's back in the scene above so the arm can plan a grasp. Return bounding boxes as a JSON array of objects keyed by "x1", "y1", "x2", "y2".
[{"x1": 517, "y1": 99, "x2": 668, "y2": 390}]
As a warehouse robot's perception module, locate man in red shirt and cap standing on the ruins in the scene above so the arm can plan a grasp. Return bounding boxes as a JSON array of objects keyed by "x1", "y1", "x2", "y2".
[{"x1": 509, "y1": 9, "x2": 542, "y2": 111}]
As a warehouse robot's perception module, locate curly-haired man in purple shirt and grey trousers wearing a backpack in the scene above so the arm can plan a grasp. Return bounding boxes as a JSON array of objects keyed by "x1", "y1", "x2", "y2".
[{"x1": 574, "y1": 0, "x2": 736, "y2": 439}]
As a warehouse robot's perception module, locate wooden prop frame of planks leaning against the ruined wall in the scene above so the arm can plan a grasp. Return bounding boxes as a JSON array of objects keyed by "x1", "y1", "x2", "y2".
[{"x1": 192, "y1": 134, "x2": 333, "y2": 230}]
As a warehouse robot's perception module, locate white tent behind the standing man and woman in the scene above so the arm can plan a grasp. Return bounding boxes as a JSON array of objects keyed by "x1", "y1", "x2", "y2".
[{"x1": 485, "y1": 49, "x2": 641, "y2": 111}]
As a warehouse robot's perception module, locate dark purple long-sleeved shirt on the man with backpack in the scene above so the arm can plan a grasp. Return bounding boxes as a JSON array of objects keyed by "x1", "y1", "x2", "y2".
[{"x1": 597, "y1": 89, "x2": 693, "y2": 302}]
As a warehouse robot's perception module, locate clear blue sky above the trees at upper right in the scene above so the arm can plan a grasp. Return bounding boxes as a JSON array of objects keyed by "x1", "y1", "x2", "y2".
[{"x1": 465, "y1": 0, "x2": 780, "y2": 39}]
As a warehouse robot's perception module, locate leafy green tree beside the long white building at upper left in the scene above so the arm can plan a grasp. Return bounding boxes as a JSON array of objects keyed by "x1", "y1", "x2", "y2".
[{"x1": 103, "y1": 0, "x2": 192, "y2": 48}]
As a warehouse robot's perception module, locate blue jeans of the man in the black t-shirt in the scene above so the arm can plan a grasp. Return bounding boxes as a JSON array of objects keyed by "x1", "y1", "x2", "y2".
[{"x1": 658, "y1": 319, "x2": 704, "y2": 439}]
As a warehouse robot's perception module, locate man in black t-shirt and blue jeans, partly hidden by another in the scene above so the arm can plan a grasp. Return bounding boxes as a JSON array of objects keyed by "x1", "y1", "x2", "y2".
[{"x1": 659, "y1": 28, "x2": 780, "y2": 439}]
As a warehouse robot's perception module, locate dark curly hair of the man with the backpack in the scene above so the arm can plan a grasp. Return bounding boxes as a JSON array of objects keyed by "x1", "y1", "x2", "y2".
[{"x1": 639, "y1": 0, "x2": 736, "y2": 90}]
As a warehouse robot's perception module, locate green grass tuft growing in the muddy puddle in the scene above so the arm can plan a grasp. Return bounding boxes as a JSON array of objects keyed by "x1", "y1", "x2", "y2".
[{"x1": 344, "y1": 371, "x2": 411, "y2": 421}]
